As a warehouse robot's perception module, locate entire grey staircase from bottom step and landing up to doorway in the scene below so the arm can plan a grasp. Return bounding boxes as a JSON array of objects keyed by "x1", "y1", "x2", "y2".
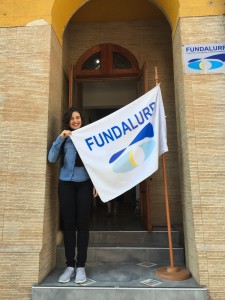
[{"x1": 32, "y1": 230, "x2": 207, "y2": 300}]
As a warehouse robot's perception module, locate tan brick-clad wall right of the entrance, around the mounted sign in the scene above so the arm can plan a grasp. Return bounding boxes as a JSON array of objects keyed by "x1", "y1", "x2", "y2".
[{"x1": 173, "y1": 16, "x2": 225, "y2": 300}]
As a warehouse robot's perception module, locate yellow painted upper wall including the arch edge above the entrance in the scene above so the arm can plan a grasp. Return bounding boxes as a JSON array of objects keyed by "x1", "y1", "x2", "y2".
[{"x1": 0, "y1": 0, "x2": 225, "y2": 42}]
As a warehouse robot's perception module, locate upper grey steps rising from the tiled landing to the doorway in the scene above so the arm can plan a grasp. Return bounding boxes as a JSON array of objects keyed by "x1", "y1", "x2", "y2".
[{"x1": 56, "y1": 230, "x2": 184, "y2": 268}]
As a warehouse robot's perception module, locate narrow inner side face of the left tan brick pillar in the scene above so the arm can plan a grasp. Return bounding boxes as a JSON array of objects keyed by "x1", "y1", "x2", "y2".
[{"x1": 39, "y1": 27, "x2": 63, "y2": 282}]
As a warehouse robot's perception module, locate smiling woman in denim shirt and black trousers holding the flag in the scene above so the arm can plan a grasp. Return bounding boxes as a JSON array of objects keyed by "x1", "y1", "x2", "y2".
[{"x1": 48, "y1": 108, "x2": 97, "y2": 283}]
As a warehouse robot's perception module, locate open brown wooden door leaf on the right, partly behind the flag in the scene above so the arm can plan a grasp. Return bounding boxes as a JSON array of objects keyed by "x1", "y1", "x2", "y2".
[{"x1": 138, "y1": 62, "x2": 152, "y2": 231}]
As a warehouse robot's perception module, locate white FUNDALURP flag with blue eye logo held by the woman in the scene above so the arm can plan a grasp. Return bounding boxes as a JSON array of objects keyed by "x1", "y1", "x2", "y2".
[{"x1": 71, "y1": 85, "x2": 168, "y2": 202}]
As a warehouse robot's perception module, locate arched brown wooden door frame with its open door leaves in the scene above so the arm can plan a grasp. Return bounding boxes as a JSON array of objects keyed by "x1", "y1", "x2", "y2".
[{"x1": 68, "y1": 44, "x2": 152, "y2": 231}]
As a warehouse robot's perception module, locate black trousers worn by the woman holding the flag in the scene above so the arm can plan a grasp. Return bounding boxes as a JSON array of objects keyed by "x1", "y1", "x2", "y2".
[{"x1": 58, "y1": 180, "x2": 93, "y2": 267}]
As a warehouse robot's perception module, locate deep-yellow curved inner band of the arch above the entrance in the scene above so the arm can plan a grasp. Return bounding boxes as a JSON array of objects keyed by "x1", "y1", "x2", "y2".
[{"x1": 51, "y1": 0, "x2": 180, "y2": 43}]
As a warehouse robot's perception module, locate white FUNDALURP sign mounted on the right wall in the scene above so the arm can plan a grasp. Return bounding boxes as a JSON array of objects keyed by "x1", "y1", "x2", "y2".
[{"x1": 183, "y1": 43, "x2": 225, "y2": 74}]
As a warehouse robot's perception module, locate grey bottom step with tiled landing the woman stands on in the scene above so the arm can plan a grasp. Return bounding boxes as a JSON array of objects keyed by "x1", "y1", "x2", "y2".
[{"x1": 32, "y1": 262, "x2": 207, "y2": 300}]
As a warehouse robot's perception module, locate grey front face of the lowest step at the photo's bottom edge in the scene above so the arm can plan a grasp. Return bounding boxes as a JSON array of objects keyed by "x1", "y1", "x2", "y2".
[{"x1": 32, "y1": 287, "x2": 208, "y2": 300}]
